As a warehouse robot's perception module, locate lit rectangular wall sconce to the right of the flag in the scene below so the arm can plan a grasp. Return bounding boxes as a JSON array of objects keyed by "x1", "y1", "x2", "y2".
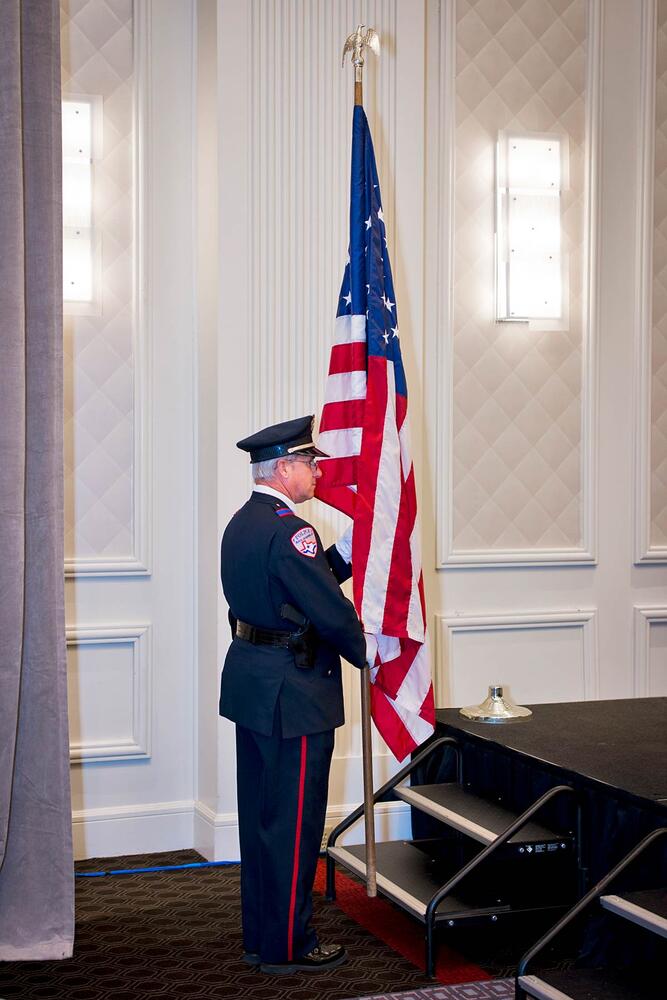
[{"x1": 496, "y1": 131, "x2": 569, "y2": 330}]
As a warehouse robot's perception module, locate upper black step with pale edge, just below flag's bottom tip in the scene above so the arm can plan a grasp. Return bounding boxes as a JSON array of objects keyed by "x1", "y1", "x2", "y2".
[{"x1": 395, "y1": 783, "x2": 570, "y2": 854}]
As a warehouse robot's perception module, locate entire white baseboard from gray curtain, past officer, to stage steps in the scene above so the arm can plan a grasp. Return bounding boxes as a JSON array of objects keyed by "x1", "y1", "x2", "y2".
[{"x1": 72, "y1": 800, "x2": 410, "y2": 861}]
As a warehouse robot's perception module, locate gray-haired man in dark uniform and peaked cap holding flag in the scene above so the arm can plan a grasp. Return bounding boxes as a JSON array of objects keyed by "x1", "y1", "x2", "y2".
[{"x1": 220, "y1": 416, "x2": 366, "y2": 974}]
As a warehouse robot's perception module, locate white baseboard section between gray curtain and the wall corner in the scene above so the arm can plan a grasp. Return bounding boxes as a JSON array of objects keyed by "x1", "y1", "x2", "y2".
[{"x1": 72, "y1": 799, "x2": 194, "y2": 861}]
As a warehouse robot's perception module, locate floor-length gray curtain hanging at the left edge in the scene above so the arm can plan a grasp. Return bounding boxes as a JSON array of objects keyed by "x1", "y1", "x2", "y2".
[{"x1": 0, "y1": 0, "x2": 74, "y2": 960}]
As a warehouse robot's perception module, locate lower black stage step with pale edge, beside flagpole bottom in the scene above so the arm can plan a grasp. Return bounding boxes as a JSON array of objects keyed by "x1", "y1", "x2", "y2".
[{"x1": 329, "y1": 840, "x2": 510, "y2": 923}]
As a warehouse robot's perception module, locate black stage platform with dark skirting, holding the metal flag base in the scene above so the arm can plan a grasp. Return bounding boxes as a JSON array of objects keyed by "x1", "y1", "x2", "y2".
[{"x1": 411, "y1": 698, "x2": 667, "y2": 954}]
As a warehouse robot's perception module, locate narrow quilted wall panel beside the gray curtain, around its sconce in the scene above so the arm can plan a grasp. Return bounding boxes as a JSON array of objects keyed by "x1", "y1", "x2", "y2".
[{"x1": 61, "y1": 0, "x2": 134, "y2": 560}]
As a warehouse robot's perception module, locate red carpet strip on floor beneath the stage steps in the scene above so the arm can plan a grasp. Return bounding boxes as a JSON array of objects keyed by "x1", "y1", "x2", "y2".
[{"x1": 315, "y1": 859, "x2": 492, "y2": 985}]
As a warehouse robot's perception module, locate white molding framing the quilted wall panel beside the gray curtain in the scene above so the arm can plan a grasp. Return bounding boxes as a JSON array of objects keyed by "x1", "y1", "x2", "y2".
[{"x1": 65, "y1": 0, "x2": 155, "y2": 577}]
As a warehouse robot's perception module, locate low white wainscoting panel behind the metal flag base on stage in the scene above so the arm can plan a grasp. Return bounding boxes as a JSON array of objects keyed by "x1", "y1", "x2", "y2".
[{"x1": 436, "y1": 610, "x2": 599, "y2": 706}]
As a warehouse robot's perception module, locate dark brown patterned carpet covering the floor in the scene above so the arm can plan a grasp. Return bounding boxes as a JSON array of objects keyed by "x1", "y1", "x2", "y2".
[{"x1": 0, "y1": 851, "x2": 568, "y2": 1000}]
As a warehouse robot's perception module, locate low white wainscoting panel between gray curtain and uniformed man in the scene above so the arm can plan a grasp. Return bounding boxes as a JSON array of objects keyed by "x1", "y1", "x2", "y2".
[{"x1": 66, "y1": 625, "x2": 152, "y2": 763}]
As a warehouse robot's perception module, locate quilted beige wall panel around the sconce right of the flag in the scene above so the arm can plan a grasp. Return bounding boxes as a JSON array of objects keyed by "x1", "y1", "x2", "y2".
[{"x1": 452, "y1": 0, "x2": 587, "y2": 551}]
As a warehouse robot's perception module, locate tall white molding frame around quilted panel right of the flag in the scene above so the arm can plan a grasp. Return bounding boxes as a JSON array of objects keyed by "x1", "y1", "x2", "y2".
[{"x1": 436, "y1": 0, "x2": 602, "y2": 569}]
